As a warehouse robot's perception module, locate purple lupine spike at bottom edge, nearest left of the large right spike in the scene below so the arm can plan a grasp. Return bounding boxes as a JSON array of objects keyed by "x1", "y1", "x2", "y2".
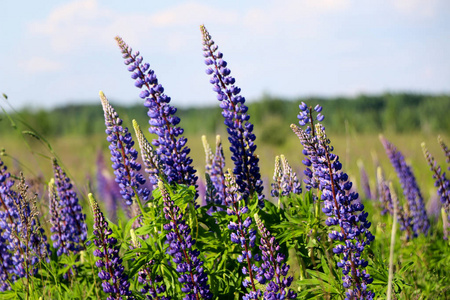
[{"x1": 254, "y1": 214, "x2": 297, "y2": 299}]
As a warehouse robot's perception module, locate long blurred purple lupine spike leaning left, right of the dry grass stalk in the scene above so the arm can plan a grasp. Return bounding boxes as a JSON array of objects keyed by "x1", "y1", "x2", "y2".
[{"x1": 380, "y1": 135, "x2": 430, "y2": 235}]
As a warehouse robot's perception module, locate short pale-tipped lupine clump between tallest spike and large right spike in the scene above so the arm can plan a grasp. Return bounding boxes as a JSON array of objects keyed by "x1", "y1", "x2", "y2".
[{"x1": 270, "y1": 155, "x2": 302, "y2": 197}]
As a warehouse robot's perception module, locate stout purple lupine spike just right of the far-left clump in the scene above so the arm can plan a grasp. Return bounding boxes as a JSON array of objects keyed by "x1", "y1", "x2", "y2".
[{"x1": 50, "y1": 159, "x2": 87, "y2": 255}]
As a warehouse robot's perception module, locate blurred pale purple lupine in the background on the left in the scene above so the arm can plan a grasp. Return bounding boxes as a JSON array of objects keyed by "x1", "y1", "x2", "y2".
[{"x1": 96, "y1": 151, "x2": 121, "y2": 223}]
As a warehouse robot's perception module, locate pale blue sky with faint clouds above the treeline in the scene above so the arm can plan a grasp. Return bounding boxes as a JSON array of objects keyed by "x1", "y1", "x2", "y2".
[{"x1": 0, "y1": 0, "x2": 450, "y2": 108}]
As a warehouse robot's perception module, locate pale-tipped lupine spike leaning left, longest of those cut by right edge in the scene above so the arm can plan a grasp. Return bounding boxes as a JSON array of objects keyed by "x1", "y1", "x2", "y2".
[{"x1": 422, "y1": 143, "x2": 450, "y2": 237}]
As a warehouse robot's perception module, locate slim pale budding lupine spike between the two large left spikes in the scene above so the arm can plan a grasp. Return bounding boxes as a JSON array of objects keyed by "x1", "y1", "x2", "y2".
[{"x1": 133, "y1": 120, "x2": 163, "y2": 185}]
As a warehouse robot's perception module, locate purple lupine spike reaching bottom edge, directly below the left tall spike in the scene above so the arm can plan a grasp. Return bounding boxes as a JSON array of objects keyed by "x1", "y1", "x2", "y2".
[{"x1": 158, "y1": 181, "x2": 213, "y2": 300}]
